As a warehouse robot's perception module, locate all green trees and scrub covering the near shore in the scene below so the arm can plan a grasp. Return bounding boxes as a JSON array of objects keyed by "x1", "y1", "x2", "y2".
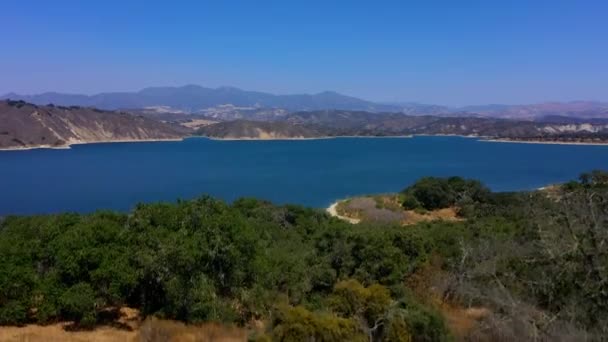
[{"x1": 0, "y1": 172, "x2": 608, "y2": 341}]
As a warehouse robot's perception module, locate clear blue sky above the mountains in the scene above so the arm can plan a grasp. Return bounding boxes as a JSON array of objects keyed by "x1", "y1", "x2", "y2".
[{"x1": 0, "y1": 0, "x2": 608, "y2": 106}]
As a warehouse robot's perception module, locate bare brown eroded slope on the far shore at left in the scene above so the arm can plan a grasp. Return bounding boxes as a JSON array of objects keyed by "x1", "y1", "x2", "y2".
[{"x1": 0, "y1": 101, "x2": 188, "y2": 149}]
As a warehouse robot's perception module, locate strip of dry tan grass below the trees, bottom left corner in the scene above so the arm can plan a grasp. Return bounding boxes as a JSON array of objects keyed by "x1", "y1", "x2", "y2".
[{"x1": 0, "y1": 308, "x2": 247, "y2": 342}]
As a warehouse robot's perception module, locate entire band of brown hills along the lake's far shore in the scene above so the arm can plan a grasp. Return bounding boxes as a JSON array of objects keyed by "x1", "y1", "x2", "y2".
[{"x1": 5, "y1": 100, "x2": 608, "y2": 148}]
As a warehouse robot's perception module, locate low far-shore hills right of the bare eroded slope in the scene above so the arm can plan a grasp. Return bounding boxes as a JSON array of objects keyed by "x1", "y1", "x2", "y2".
[{"x1": 197, "y1": 110, "x2": 608, "y2": 143}]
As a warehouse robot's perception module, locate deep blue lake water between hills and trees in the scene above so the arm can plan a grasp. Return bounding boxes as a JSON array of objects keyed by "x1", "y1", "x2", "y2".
[{"x1": 0, "y1": 137, "x2": 608, "y2": 215}]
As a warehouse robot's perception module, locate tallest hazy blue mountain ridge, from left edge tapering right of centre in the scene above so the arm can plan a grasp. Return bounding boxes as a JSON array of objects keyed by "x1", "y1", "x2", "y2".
[{"x1": 0, "y1": 85, "x2": 400, "y2": 112}]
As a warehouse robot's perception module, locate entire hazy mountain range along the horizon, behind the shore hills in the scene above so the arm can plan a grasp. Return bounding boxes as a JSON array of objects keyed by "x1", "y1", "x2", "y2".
[{"x1": 0, "y1": 85, "x2": 608, "y2": 120}]
